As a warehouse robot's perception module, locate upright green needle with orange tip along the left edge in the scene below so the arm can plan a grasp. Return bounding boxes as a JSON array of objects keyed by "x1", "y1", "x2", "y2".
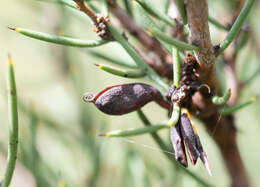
[{"x1": 1, "y1": 57, "x2": 18, "y2": 187}]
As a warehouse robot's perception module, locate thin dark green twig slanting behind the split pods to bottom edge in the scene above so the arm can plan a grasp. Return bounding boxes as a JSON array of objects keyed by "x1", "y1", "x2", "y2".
[{"x1": 137, "y1": 110, "x2": 211, "y2": 187}]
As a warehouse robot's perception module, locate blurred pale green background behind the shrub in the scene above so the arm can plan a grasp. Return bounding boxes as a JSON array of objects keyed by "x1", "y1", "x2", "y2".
[{"x1": 0, "y1": 0, "x2": 260, "y2": 187}]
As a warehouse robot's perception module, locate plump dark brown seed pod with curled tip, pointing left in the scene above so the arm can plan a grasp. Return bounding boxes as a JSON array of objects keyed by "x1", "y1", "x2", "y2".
[{"x1": 83, "y1": 83, "x2": 170, "y2": 115}]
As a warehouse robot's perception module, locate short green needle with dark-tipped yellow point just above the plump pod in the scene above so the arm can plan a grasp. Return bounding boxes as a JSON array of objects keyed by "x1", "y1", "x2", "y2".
[{"x1": 96, "y1": 64, "x2": 145, "y2": 78}]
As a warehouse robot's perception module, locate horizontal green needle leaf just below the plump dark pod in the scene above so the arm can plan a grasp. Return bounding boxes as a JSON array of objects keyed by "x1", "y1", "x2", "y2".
[{"x1": 100, "y1": 125, "x2": 169, "y2": 138}]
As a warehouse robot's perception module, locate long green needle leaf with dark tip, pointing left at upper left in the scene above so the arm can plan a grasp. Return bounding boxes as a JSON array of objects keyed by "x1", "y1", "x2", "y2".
[{"x1": 8, "y1": 27, "x2": 109, "y2": 47}]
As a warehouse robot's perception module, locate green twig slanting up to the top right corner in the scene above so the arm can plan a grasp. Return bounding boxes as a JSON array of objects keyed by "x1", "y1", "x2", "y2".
[{"x1": 218, "y1": 0, "x2": 255, "y2": 55}]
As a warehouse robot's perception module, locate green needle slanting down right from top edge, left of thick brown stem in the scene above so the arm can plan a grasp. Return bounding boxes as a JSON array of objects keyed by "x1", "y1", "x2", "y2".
[{"x1": 135, "y1": 0, "x2": 175, "y2": 27}]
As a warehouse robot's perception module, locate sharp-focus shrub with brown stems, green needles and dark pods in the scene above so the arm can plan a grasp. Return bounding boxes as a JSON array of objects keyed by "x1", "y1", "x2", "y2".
[{"x1": 9, "y1": 0, "x2": 257, "y2": 186}]
